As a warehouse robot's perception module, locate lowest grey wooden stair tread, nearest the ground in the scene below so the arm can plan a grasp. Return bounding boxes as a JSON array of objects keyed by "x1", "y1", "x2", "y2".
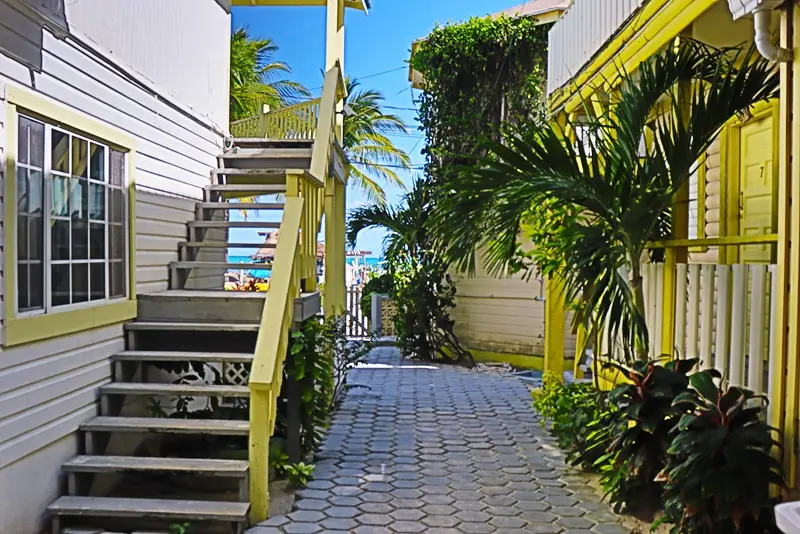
[{"x1": 47, "y1": 497, "x2": 250, "y2": 523}]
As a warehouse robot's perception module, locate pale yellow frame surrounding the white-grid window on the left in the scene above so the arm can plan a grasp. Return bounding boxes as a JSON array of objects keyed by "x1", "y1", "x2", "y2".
[{"x1": 3, "y1": 86, "x2": 136, "y2": 347}]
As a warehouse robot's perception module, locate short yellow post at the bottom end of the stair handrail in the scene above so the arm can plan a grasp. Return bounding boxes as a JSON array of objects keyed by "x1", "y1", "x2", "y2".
[{"x1": 250, "y1": 387, "x2": 272, "y2": 524}]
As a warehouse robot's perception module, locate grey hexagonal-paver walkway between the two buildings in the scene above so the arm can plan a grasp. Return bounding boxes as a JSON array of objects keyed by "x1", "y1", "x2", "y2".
[{"x1": 249, "y1": 348, "x2": 628, "y2": 534}]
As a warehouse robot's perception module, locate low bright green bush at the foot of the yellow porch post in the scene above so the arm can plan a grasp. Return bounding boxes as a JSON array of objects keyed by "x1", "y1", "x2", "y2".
[{"x1": 531, "y1": 372, "x2": 617, "y2": 467}]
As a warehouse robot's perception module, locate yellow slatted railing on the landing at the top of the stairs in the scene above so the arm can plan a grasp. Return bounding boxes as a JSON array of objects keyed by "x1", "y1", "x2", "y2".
[{"x1": 231, "y1": 98, "x2": 322, "y2": 141}]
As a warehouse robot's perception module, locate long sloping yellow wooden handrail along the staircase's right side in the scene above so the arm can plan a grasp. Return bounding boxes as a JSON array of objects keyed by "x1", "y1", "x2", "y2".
[{"x1": 249, "y1": 61, "x2": 345, "y2": 523}]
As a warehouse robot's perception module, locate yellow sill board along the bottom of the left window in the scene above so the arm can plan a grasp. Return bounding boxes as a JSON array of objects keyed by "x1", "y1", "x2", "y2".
[{"x1": 5, "y1": 300, "x2": 136, "y2": 347}]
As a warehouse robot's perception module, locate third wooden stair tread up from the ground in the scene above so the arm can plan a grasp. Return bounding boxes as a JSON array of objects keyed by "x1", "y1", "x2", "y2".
[{"x1": 80, "y1": 416, "x2": 250, "y2": 436}]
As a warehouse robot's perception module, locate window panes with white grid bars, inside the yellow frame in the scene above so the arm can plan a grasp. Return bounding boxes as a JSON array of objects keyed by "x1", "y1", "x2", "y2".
[{"x1": 16, "y1": 115, "x2": 128, "y2": 315}]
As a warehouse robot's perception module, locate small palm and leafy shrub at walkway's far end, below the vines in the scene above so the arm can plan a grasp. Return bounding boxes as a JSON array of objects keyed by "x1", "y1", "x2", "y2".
[{"x1": 347, "y1": 180, "x2": 474, "y2": 365}]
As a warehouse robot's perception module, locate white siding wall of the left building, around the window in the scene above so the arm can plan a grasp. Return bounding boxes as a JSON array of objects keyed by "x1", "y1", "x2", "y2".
[{"x1": 0, "y1": 0, "x2": 229, "y2": 534}]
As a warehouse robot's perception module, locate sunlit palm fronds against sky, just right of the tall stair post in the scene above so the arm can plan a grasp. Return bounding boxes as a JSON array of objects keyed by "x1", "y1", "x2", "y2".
[{"x1": 342, "y1": 78, "x2": 411, "y2": 204}]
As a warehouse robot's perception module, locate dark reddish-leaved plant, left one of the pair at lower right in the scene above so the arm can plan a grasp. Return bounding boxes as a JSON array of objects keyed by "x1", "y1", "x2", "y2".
[{"x1": 598, "y1": 360, "x2": 697, "y2": 512}]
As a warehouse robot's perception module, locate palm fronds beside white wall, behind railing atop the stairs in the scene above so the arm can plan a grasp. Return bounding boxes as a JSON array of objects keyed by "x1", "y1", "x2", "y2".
[{"x1": 230, "y1": 28, "x2": 310, "y2": 121}]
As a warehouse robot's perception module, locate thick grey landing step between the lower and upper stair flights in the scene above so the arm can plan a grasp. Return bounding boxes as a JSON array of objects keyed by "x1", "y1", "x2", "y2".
[{"x1": 136, "y1": 292, "x2": 268, "y2": 324}]
